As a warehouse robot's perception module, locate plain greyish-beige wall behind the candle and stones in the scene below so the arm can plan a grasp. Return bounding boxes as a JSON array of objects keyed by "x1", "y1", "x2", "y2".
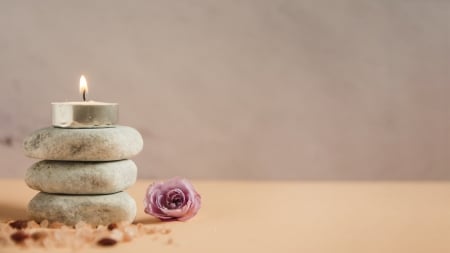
[{"x1": 0, "y1": 0, "x2": 450, "y2": 179}]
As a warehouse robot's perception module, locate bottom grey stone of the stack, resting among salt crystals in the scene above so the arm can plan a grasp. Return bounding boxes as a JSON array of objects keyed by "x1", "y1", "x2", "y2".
[{"x1": 28, "y1": 192, "x2": 136, "y2": 226}]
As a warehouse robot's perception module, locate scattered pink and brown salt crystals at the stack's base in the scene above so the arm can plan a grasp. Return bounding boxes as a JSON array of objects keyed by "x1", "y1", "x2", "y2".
[{"x1": 0, "y1": 220, "x2": 174, "y2": 249}]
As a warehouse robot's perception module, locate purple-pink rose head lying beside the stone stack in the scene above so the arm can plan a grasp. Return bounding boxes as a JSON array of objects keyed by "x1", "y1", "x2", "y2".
[{"x1": 144, "y1": 178, "x2": 201, "y2": 221}]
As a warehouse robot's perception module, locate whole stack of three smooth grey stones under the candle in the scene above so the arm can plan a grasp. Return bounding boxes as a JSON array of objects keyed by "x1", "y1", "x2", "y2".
[{"x1": 24, "y1": 126, "x2": 143, "y2": 225}]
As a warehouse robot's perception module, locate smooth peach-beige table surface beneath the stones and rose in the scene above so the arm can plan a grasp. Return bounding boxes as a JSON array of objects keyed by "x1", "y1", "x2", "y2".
[{"x1": 0, "y1": 179, "x2": 450, "y2": 253}]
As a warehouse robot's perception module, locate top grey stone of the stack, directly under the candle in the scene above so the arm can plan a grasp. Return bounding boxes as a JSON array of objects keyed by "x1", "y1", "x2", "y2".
[{"x1": 24, "y1": 126, "x2": 144, "y2": 161}]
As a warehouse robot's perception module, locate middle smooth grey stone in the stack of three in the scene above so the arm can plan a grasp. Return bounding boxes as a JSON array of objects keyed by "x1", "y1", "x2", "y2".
[{"x1": 25, "y1": 160, "x2": 137, "y2": 194}]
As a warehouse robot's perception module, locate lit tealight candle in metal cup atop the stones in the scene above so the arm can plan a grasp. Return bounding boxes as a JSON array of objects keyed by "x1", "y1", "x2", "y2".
[{"x1": 52, "y1": 76, "x2": 119, "y2": 128}]
